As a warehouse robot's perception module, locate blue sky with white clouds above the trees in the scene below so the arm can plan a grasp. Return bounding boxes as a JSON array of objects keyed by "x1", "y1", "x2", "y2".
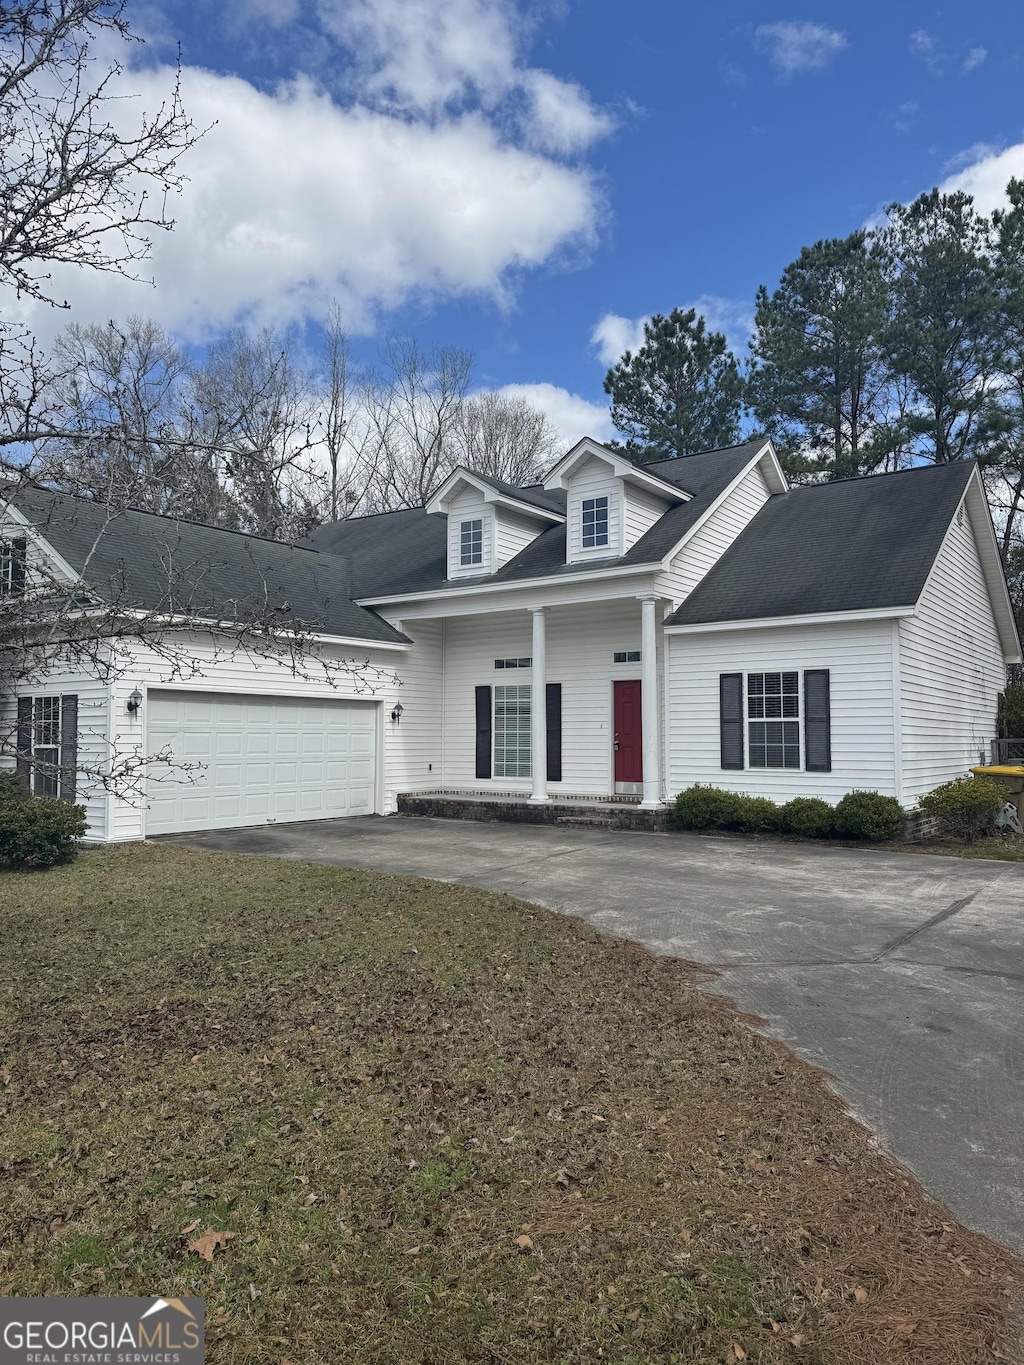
[{"x1": 16, "y1": 0, "x2": 1024, "y2": 437}]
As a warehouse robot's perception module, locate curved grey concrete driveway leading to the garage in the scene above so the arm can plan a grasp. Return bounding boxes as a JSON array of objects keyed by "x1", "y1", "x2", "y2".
[{"x1": 160, "y1": 818, "x2": 1024, "y2": 1252}]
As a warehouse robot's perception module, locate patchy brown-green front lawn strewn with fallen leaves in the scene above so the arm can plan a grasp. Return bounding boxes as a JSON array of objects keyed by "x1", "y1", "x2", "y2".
[{"x1": 0, "y1": 845, "x2": 1024, "y2": 1365}]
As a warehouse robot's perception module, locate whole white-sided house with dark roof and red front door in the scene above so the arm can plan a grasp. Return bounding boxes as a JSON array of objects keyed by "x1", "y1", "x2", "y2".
[{"x1": 0, "y1": 440, "x2": 1021, "y2": 839}]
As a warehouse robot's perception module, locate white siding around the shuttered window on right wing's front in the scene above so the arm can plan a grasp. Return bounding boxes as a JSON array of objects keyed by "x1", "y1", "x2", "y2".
[{"x1": 668, "y1": 621, "x2": 897, "y2": 801}]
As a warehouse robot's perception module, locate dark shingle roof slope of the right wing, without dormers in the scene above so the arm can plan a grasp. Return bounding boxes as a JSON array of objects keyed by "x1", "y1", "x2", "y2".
[{"x1": 668, "y1": 461, "x2": 975, "y2": 625}]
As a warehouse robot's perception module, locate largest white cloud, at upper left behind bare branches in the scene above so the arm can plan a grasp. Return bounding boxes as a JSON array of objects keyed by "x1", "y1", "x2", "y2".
[{"x1": 8, "y1": 53, "x2": 603, "y2": 346}]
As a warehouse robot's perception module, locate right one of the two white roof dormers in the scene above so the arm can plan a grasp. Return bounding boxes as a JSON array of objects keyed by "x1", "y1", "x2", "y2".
[{"x1": 543, "y1": 438, "x2": 689, "y2": 564}]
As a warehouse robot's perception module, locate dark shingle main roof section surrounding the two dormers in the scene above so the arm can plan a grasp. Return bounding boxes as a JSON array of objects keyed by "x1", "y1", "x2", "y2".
[{"x1": 307, "y1": 437, "x2": 766, "y2": 598}]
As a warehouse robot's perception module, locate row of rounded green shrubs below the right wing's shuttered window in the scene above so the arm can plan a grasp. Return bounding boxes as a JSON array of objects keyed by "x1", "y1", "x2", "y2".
[{"x1": 673, "y1": 785, "x2": 905, "y2": 842}]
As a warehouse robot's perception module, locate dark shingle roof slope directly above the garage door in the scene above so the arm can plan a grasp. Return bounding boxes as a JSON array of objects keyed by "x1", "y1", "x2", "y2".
[{"x1": 9, "y1": 487, "x2": 406, "y2": 643}]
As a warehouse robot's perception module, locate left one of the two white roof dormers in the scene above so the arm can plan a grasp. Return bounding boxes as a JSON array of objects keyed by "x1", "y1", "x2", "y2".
[{"x1": 426, "y1": 468, "x2": 565, "y2": 579}]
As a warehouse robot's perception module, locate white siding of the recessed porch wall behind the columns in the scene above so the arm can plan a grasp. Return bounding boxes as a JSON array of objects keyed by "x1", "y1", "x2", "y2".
[{"x1": 442, "y1": 599, "x2": 658, "y2": 796}]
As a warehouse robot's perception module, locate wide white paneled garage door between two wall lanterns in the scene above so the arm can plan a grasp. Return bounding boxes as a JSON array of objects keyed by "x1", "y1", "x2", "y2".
[{"x1": 146, "y1": 691, "x2": 377, "y2": 834}]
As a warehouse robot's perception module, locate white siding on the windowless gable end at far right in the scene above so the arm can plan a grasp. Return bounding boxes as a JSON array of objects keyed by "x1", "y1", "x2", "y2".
[{"x1": 898, "y1": 516, "x2": 1006, "y2": 800}]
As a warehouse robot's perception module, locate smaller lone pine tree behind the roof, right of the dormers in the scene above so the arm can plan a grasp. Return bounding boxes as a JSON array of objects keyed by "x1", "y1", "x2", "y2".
[{"x1": 605, "y1": 308, "x2": 743, "y2": 464}]
